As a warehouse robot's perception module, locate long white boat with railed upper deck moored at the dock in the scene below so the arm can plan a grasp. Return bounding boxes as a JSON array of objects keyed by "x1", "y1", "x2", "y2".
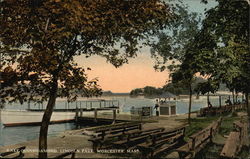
[{"x1": 0, "y1": 100, "x2": 119, "y2": 127}]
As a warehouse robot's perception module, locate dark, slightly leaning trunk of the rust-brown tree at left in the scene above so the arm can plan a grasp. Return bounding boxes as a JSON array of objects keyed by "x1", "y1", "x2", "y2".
[{"x1": 39, "y1": 79, "x2": 58, "y2": 158}]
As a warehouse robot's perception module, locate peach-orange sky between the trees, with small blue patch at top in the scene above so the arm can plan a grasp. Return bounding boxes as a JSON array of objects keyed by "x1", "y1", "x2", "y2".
[{"x1": 75, "y1": 0, "x2": 216, "y2": 93}]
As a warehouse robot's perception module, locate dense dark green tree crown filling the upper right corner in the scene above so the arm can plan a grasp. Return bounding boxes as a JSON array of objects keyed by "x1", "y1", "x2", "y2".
[{"x1": 186, "y1": 0, "x2": 250, "y2": 121}]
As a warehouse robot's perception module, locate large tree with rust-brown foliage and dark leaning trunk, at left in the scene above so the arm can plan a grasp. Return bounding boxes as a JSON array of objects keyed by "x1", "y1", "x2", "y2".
[{"x1": 0, "y1": 0, "x2": 172, "y2": 158}]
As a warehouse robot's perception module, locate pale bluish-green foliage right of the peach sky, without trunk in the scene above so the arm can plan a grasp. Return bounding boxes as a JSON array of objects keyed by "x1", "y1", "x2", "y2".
[{"x1": 151, "y1": 2, "x2": 201, "y2": 71}]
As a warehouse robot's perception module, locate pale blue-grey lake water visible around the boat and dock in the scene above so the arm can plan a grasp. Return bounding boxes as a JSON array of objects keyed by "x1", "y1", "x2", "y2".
[{"x1": 0, "y1": 96, "x2": 240, "y2": 146}]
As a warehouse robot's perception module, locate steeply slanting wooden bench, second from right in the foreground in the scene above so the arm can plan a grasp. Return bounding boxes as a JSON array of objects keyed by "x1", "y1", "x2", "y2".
[{"x1": 176, "y1": 118, "x2": 222, "y2": 158}]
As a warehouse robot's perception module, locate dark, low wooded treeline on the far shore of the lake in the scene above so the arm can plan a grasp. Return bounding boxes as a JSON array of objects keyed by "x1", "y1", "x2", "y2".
[{"x1": 130, "y1": 77, "x2": 228, "y2": 96}]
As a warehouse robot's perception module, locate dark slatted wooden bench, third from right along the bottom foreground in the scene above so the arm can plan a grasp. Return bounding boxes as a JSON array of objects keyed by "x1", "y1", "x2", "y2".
[{"x1": 137, "y1": 126, "x2": 186, "y2": 158}]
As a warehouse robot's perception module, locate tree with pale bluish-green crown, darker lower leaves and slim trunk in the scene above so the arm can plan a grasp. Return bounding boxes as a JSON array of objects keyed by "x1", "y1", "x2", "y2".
[{"x1": 151, "y1": 3, "x2": 201, "y2": 124}]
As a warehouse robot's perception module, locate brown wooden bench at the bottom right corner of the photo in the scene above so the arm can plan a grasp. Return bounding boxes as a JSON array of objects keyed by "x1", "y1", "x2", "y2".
[{"x1": 220, "y1": 121, "x2": 249, "y2": 158}]
